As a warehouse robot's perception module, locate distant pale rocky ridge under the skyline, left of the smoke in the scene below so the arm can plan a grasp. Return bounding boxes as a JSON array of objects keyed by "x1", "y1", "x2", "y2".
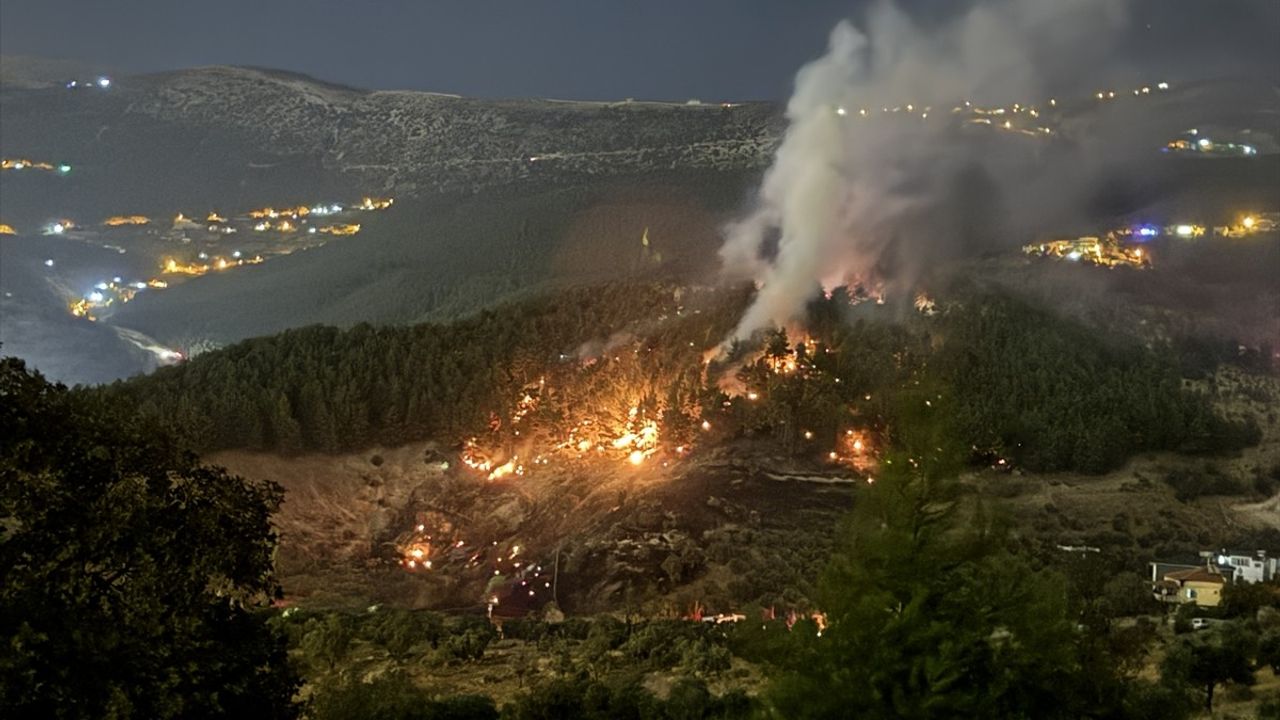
[{"x1": 0, "y1": 61, "x2": 781, "y2": 223}]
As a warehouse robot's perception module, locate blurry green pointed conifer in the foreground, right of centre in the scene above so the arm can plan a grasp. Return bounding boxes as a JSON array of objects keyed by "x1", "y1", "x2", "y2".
[{"x1": 737, "y1": 425, "x2": 1146, "y2": 717}]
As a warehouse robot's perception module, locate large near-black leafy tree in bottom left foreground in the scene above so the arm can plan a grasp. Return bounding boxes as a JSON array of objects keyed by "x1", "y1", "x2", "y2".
[{"x1": 0, "y1": 359, "x2": 297, "y2": 717}]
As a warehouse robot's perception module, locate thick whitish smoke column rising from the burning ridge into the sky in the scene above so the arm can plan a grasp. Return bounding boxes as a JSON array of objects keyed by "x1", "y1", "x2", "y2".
[{"x1": 721, "y1": 0, "x2": 1126, "y2": 338}]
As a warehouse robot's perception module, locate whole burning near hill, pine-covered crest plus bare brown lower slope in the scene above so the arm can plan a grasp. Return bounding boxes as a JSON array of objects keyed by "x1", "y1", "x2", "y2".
[{"x1": 93, "y1": 284, "x2": 1280, "y2": 616}]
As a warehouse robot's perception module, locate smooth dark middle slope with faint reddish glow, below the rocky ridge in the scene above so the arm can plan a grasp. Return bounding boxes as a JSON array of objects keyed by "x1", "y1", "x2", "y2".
[{"x1": 113, "y1": 172, "x2": 749, "y2": 347}]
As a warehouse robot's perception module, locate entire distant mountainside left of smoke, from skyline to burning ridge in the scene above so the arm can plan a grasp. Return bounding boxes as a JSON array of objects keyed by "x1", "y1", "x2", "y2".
[{"x1": 0, "y1": 60, "x2": 782, "y2": 380}]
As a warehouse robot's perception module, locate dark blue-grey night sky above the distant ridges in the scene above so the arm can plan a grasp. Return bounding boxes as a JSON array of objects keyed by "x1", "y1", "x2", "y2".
[{"x1": 0, "y1": 0, "x2": 1280, "y2": 100}]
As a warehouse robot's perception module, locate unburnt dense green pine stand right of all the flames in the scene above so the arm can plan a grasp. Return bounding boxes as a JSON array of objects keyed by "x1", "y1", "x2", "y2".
[{"x1": 932, "y1": 296, "x2": 1261, "y2": 473}]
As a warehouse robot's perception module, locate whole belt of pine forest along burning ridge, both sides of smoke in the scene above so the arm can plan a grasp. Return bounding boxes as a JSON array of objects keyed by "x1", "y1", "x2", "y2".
[{"x1": 90, "y1": 284, "x2": 1260, "y2": 473}]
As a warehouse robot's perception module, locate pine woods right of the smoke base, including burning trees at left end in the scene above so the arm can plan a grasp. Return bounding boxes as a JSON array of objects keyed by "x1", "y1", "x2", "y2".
[{"x1": 732, "y1": 288, "x2": 1261, "y2": 473}]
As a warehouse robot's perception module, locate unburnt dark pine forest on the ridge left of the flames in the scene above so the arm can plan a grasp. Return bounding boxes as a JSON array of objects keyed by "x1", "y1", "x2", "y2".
[{"x1": 97, "y1": 284, "x2": 747, "y2": 452}]
